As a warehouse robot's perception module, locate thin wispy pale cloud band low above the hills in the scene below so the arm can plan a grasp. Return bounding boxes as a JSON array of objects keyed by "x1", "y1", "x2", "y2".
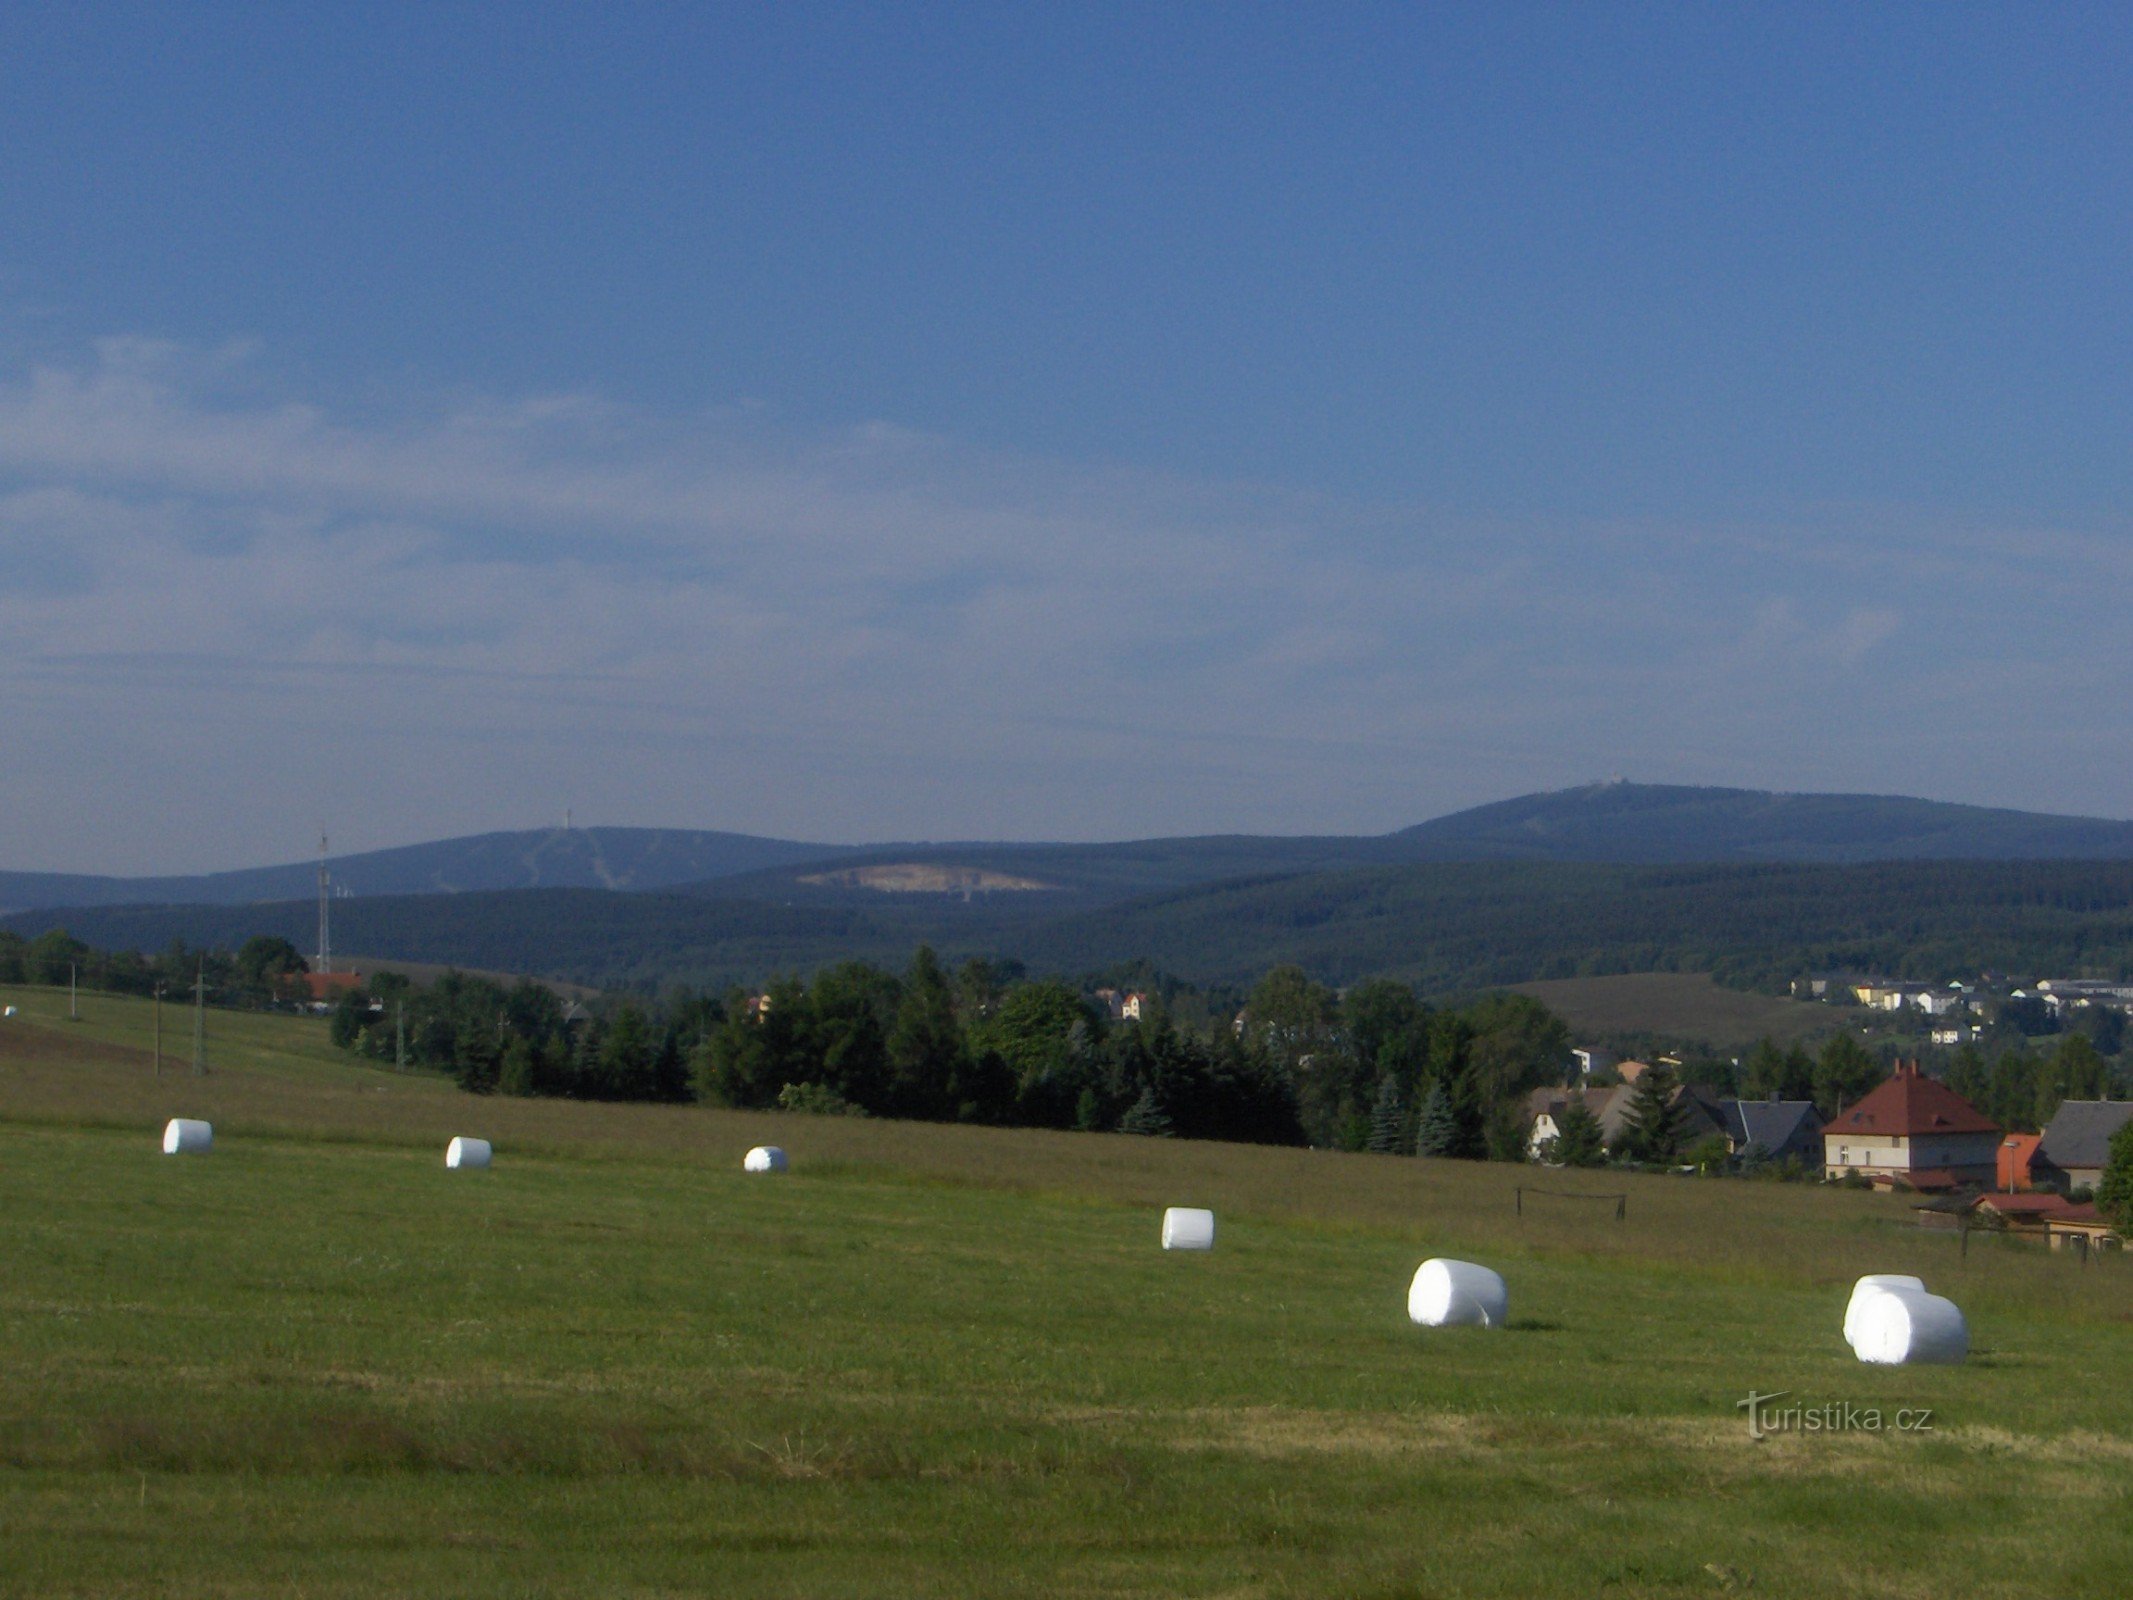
[{"x1": 0, "y1": 341, "x2": 2124, "y2": 868}]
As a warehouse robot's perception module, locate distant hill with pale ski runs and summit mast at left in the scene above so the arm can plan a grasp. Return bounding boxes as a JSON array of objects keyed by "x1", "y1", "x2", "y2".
[{"x1": 0, "y1": 828, "x2": 843, "y2": 911}]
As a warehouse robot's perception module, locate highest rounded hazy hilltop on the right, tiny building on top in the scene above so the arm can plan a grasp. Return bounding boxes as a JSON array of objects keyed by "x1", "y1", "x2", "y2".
[{"x1": 1395, "y1": 779, "x2": 2133, "y2": 864}]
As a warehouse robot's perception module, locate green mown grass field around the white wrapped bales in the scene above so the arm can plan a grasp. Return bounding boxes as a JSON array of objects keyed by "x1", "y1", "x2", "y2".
[{"x1": 0, "y1": 990, "x2": 2133, "y2": 1598}]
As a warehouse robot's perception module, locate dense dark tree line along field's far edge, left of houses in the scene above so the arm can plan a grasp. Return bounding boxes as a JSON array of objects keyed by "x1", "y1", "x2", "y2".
[{"x1": 333, "y1": 947, "x2": 1568, "y2": 1161}]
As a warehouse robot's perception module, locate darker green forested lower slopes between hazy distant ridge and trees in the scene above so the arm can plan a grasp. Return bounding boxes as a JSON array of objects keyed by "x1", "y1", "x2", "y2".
[{"x1": 25, "y1": 862, "x2": 2133, "y2": 992}]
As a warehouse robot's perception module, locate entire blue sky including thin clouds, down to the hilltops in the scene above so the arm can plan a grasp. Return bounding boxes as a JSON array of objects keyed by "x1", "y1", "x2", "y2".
[{"x1": 0, "y1": 4, "x2": 2133, "y2": 870}]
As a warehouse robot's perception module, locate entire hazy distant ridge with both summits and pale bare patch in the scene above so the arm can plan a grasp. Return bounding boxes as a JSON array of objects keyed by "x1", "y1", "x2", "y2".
[{"x1": 12, "y1": 783, "x2": 2133, "y2": 919}]
